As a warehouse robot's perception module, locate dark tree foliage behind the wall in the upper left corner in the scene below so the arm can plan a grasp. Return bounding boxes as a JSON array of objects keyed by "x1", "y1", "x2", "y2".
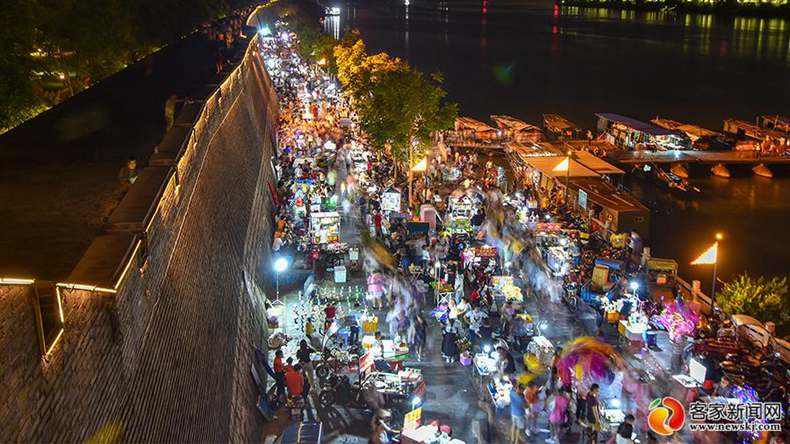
[{"x1": 0, "y1": 0, "x2": 251, "y2": 133}]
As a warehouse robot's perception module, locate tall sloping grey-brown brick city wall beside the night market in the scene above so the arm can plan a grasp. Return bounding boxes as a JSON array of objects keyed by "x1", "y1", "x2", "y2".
[{"x1": 0, "y1": 35, "x2": 278, "y2": 442}]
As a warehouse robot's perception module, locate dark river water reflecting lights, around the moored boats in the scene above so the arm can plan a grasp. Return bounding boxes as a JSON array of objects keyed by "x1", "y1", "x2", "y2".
[{"x1": 326, "y1": 0, "x2": 790, "y2": 289}]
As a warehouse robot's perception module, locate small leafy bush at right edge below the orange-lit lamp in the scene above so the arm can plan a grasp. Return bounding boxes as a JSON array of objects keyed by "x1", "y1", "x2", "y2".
[{"x1": 716, "y1": 273, "x2": 790, "y2": 333}]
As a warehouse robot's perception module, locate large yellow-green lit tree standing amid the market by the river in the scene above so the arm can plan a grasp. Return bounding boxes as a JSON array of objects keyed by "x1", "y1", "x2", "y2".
[{"x1": 335, "y1": 40, "x2": 458, "y2": 162}]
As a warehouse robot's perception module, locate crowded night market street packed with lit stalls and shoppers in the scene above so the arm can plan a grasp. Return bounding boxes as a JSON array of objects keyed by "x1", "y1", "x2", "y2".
[{"x1": 262, "y1": 20, "x2": 784, "y2": 443}]
